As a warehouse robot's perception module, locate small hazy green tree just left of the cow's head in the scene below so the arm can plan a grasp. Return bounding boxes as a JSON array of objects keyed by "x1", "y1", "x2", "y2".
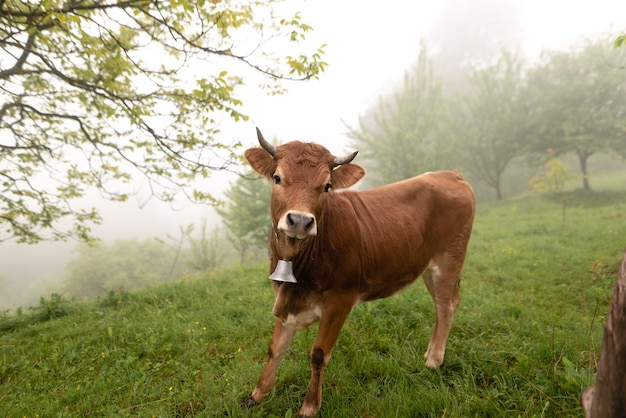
[{"x1": 216, "y1": 174, "x2": 272, "y2": 264}]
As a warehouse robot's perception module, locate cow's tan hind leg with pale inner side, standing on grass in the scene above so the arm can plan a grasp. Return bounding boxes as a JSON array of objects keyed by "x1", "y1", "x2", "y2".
[{"x1": 422, "y1": 257, "x2": 462, "y2": 369}]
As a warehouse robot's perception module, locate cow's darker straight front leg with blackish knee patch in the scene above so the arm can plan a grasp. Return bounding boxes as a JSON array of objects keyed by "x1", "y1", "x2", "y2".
[{"x1": 298, "y1": 301, "x2": 352, "y2": 418}]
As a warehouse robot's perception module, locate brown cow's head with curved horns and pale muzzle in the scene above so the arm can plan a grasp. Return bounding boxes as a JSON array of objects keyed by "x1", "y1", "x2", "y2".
[{"x1": 245, "y1": 128, "x2": 365, "y2": 260}]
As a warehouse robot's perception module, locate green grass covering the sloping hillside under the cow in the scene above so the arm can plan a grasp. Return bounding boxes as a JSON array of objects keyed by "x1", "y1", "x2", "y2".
[{"x1": 0, "y1": 192, "x2": 626, "y2": 418}]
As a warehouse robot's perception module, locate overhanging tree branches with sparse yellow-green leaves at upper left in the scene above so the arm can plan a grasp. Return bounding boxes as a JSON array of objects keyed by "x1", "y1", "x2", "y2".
[{"x1": 0, "y1": 0, "x2": 326, "y2": 243}]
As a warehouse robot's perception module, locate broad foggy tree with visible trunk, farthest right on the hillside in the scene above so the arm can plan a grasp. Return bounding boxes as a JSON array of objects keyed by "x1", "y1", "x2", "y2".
[{"x1": 529, "y1": 40, "x2": 626, "y2": 190}]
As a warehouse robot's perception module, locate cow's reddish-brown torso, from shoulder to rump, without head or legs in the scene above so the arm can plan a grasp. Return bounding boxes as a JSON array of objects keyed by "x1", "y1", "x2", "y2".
[{"x1": 319, "y1": 171, "x2": 474, "y2": 300}]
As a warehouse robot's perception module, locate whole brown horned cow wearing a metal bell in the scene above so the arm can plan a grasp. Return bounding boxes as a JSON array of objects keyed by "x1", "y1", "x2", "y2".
[{"x1": 245, "y1": 129, "x2": 474, "y2": 417}]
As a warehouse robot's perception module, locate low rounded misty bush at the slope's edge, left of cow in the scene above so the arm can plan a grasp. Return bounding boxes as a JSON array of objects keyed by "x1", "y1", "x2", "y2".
[{"x1": 63, "y1": 239, "x2": 182, "y2": 298}]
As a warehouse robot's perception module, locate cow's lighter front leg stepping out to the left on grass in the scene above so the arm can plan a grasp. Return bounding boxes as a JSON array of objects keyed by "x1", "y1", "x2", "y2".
[{"x1": 245, "y1": 319, "x2": 296, "y2": 407}]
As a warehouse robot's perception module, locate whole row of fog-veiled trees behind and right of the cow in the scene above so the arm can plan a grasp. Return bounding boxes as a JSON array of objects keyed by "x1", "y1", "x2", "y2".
[{"x1": 349, "y1": 36, "x2": 626, "y2": 199}]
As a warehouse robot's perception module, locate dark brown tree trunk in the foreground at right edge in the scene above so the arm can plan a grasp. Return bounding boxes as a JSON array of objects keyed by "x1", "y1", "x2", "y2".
[{"x1": 580, "y1": 253, "x2": 626, "y2": 418}]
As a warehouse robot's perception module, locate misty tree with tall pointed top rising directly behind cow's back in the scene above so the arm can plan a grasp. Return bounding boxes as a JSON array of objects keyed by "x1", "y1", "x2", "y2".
[{"x1": 348, "y1": 43, "x2": 448, "y2": 185}]
